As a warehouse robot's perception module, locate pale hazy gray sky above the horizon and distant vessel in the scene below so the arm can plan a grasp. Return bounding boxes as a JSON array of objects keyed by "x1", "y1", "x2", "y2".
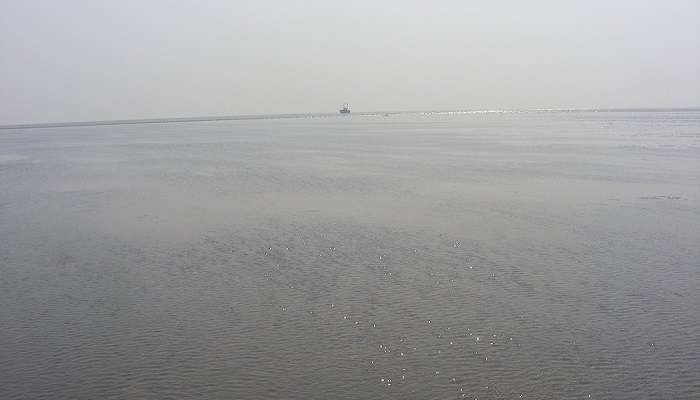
[{"x1": 0, "y1": 0, "x2": 700, "y2": 124}]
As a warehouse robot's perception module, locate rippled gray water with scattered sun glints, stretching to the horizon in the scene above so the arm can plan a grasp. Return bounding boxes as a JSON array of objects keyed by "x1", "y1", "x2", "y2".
[{"x1": 0, "y1": 111, "x2": 700, "y2": 399}]
